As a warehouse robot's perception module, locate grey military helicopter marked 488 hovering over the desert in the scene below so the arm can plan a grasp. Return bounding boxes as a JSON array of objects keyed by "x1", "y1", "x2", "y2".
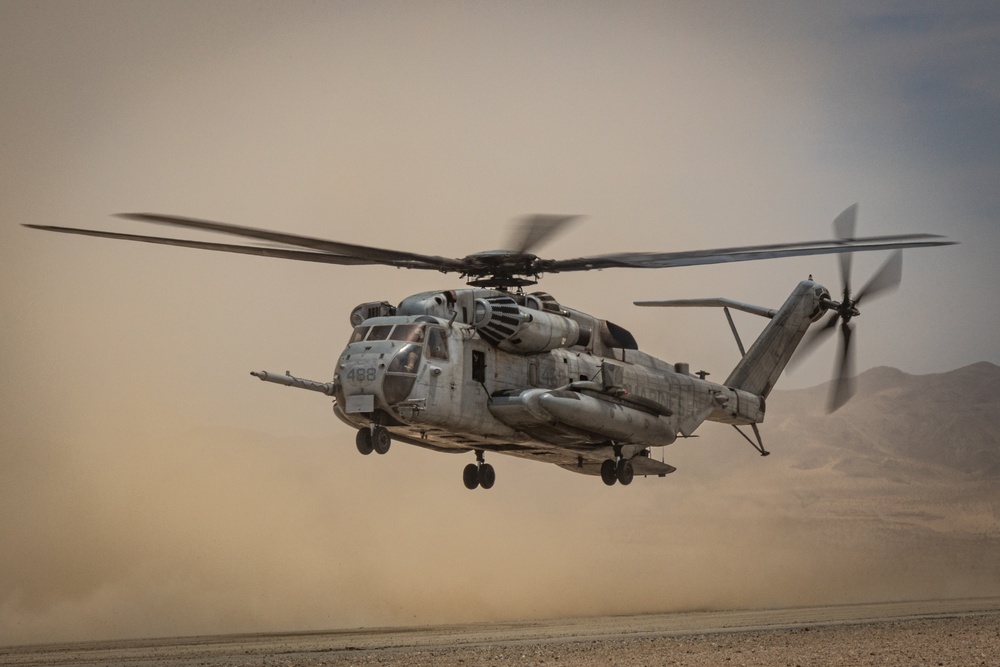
[{"x1": 26, "y1": 205, "x2": 951, "y2": 489}]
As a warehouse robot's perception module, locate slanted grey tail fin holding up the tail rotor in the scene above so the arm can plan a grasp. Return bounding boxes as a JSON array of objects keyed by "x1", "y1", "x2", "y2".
[{"x1": 725, "y1": 280, "x2": 830, "y2": 397}]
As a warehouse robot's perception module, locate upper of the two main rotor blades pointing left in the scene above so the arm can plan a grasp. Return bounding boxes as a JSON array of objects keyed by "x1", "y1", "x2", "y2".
[{"x1": 118, "y1": 213, "x2": 466, "y2": 272}]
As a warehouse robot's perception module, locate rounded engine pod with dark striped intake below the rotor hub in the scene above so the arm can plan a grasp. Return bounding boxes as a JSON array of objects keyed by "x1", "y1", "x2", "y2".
[{"x1": 472, "y1": 296, "x2": 580, "y2": 354}]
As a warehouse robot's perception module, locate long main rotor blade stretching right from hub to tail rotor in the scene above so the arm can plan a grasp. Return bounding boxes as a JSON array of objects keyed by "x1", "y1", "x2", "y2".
[{"x1": 539, "y1": 234, "x2": 955, "y2": 273}]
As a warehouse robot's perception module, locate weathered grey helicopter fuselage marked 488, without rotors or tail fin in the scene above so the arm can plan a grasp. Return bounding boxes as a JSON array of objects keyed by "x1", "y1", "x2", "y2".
[{"x1": 333, "y1": 288, "x2": 764, "y2": 474}]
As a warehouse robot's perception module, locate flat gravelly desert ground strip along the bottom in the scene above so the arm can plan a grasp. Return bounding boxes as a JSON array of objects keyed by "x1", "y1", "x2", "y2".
[{"x1": 0, "y1": 598, "x2": 1000, "y2": 667}]
